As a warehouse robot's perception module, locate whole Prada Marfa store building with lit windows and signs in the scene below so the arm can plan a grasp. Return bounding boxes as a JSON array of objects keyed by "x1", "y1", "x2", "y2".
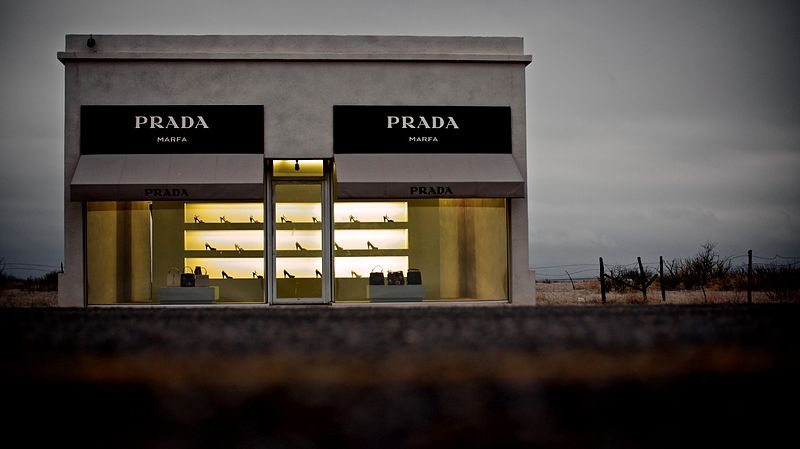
[{"x1": 58, "y1": 35, "x2": 535, "y2": 307}]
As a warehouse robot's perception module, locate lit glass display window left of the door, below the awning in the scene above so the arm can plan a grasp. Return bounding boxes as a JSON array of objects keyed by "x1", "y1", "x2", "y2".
[{"x1": 86, "y1": 201, "x2": 264, "y2": 305}]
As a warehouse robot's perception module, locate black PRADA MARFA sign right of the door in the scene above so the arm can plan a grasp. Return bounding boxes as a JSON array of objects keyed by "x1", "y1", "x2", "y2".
[{"x1": 333, "y1": 106, "x2": 511, "y2": 154}]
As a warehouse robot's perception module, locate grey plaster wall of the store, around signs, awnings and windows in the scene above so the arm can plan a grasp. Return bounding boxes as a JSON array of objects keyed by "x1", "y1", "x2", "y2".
[{"x1": 58, "y1": 35, "x2": 535, "y2": 306}]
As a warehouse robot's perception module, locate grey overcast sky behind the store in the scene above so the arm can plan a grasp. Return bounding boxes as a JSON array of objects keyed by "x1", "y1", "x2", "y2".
[{"x1": 0, "y1": 0, "x2": 800, "y2": 277}]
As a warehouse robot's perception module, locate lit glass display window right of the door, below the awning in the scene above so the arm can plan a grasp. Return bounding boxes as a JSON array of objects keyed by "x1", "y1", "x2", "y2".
[{"x1": 334, "y1": 199, "x2": 508, "y2": 302}]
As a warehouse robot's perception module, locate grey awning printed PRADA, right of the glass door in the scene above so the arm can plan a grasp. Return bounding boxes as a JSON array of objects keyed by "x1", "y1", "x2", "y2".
[{"x1": 335, "y1": 154, "x2": 525, "y2": 199}]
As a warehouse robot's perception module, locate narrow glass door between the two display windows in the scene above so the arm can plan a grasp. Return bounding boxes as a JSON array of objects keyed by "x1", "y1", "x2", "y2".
[{"x1": 272, "y1": 181, "x2": 331, "y2": 304}]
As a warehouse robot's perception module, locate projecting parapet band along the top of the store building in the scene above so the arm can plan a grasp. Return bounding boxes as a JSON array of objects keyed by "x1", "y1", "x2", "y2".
[{"x1": 58, "y1": 34, "x2": 532, "y2": 65}]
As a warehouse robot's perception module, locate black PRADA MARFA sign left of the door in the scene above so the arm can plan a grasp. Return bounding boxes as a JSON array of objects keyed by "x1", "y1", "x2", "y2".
[{"x1": 81, "y1": 105, "x2": 264, "y2": 154}]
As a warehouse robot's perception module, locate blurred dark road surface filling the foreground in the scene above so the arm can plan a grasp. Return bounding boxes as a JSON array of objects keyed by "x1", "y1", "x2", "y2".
[{"x1": 0, "y1": 304, "x2": 800, "y2": 448}]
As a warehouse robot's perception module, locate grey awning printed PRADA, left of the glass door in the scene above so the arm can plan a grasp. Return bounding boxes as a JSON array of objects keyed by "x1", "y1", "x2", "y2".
[{"x1": 70, "y1": 154, "x2": 264, "y2": 201}]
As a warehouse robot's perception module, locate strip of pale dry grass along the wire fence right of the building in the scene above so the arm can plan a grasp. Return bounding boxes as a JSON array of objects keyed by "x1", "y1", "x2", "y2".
[{"x1": 536, "y1": 279, "x2": 775, "y2": 305}]
